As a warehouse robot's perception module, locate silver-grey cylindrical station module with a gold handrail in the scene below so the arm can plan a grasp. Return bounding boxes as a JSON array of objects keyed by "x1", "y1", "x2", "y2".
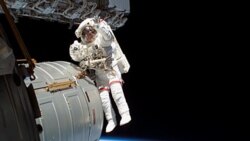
[{"x1": 24, "y1": 61, "x2": 103, "y2": 141}]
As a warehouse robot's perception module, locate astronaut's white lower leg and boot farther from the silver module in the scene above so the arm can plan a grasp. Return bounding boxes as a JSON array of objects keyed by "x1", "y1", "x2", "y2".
[{"x1": 110, "y1": 82, "x2": 131, "y2": 126}]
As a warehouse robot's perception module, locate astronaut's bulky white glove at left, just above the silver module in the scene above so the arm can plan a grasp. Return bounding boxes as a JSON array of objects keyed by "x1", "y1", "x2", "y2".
[{"x1": 69, "y1": 40, "x2": 86, "y2": 62}]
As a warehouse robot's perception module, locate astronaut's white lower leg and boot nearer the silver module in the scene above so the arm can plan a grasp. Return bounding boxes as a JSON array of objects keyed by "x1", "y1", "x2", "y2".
[{"x1": 100, "y1": 90, "x2": 116, "y2": 133}]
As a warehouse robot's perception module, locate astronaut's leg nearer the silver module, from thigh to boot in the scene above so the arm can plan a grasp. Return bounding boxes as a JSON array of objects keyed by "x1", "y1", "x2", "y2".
[{"x1": 96, "y1": 71, "x2": 117, "y2": 133}]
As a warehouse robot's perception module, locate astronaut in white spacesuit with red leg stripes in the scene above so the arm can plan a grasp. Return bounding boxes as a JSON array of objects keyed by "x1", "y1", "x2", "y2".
[{"x1": 70, "y1": 18, "x2": 131, "y2": 133}]
